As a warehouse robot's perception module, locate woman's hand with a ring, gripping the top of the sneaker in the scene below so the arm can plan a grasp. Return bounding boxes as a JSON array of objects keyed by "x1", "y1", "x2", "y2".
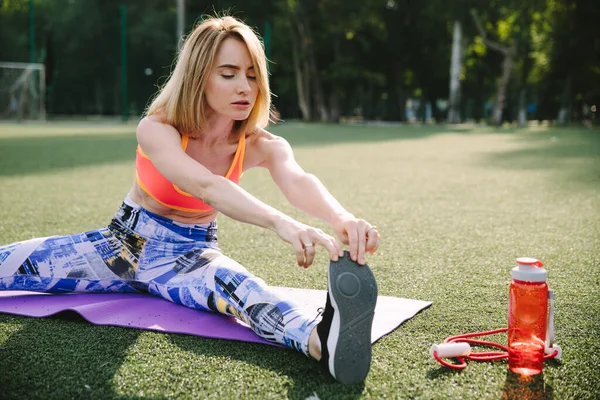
[{"x1": 333, "y1": 214, "x2": 381, "y2": 265}]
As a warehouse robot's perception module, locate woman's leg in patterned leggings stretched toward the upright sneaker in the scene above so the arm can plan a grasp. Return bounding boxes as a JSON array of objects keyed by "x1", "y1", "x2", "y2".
[{"x1": 145, "y1": 248, "x2": 318, "y2": 356}]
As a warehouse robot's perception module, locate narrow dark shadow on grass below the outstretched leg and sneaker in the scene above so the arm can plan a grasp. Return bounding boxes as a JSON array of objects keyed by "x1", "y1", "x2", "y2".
[{"x1": 170, "y1": 335, "x2": 368, "y2": 400}]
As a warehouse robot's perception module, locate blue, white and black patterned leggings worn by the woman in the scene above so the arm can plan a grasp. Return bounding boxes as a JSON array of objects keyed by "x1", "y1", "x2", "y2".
[{"x1": 0, "y1": 198, "x2": 316, "y2": 356}]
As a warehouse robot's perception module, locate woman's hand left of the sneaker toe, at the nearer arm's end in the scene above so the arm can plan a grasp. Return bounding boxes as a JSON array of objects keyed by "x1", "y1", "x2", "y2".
[{"x1": 275, "y1": 218, "x2": 344, "y2": 268}]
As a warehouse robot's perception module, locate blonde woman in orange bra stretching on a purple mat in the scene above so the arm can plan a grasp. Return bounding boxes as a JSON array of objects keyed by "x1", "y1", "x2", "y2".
[{"x1": 0, "y1": 17, "x2": 380, "y2": 383}]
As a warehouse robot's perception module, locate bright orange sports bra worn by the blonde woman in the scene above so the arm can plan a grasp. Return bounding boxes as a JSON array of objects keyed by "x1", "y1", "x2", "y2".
[{"x1": 135, "y1": 135, "x2": 246, "y2": 212}]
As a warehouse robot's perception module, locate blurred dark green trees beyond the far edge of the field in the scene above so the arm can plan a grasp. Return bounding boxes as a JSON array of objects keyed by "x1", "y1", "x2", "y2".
[{"x1": 0, "y1": 0, "x2": 600, "y2": 126}]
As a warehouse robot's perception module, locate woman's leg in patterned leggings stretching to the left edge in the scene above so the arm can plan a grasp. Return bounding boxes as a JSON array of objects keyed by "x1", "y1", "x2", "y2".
[{"x1": 0, "y1": 228, "x2": 144, "y2": 293}]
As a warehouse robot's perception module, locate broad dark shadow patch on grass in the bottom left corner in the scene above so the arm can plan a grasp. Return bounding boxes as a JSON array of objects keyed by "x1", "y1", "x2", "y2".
[{"x1": 0, "y1": 312, "x2": 141, "y2": 399}]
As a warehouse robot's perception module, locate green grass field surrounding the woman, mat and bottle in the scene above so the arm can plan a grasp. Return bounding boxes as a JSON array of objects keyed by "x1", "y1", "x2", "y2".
[{"x1": 0, "y1": 123, "x2": 600, "y2": 399}]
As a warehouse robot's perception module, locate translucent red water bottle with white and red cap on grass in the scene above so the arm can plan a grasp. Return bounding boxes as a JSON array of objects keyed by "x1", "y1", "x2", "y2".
[{"x1": 508, "y1": 257, "x2": 548, "y2": 375}]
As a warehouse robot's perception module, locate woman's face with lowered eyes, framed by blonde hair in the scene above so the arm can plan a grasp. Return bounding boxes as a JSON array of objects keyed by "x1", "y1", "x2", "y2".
[{"x1": 205, "y1": 38, "x2": 258, "y2": 120}]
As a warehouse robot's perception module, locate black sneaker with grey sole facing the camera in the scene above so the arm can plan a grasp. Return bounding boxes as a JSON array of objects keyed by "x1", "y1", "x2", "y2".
[{"x1": 317, "y1": 251, "x2": 377, "y2": 383}]
